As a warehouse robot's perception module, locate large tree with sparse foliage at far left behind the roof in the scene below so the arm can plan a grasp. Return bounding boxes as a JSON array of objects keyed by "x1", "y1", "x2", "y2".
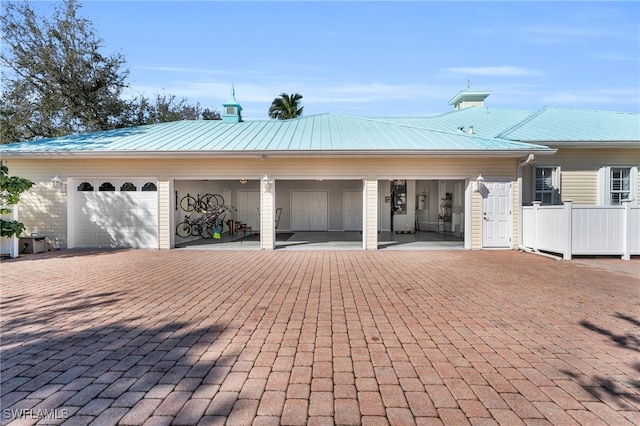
[{"x1": 0, "y1": 0, "x2": 129, "y2": 143}]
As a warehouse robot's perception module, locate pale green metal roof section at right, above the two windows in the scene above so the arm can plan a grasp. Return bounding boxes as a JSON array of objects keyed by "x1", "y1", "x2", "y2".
[{"x1": 499, "y1": 107, "x2": 640, "y2": 143}]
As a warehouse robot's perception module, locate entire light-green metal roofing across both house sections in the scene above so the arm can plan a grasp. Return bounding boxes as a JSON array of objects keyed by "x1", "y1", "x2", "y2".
[{"x1": 5, "y1": 107, "x2": 640, "y2": 157}]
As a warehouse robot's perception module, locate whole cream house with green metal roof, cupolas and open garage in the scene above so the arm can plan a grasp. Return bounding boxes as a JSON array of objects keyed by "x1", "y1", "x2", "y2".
[{"x1": 0, "y1": 90, "x2": 640, "y2": 254}]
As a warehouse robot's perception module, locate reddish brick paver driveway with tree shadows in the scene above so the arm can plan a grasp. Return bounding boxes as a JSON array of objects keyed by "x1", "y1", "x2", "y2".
[{"x1": 0, "y1": 250, "x2": 640, "y2": 425}]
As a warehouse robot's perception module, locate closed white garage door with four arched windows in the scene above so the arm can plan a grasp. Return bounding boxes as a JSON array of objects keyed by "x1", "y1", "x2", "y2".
[{"x1": 73, "y1": 179, "x2": 158, "y2": 248}]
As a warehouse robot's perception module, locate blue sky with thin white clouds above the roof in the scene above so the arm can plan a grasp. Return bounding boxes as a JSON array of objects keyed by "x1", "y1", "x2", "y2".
[{"x1": 35, "y1": 0, "x2": 640, "y2": 119}]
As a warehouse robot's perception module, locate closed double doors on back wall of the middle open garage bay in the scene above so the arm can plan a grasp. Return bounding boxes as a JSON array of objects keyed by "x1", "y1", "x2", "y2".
[{"x1": 291, "y1": 191, "x2": 328, "y2": 231}]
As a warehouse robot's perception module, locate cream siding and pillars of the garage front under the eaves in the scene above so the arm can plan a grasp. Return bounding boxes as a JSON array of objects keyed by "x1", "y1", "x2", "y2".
[{"x1": 7, "y1": 158, "x2": 517, "y2": 249}]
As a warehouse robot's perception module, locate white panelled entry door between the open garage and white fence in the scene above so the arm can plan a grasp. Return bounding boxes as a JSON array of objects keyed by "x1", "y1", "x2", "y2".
[{"x1": 482, "y1": 181, "x2": 513, "y2": 248}]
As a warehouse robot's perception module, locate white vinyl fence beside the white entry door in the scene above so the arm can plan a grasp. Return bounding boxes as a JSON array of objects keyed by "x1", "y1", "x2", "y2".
[{"x1": 522, "y1": 201, "x2": 640, "y2": 260}]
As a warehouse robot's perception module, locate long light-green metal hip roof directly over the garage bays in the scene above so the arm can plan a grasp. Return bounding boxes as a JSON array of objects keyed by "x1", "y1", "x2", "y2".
[{"x1": 0, "y1": 110, "x2": 553, "y2": 156}]
